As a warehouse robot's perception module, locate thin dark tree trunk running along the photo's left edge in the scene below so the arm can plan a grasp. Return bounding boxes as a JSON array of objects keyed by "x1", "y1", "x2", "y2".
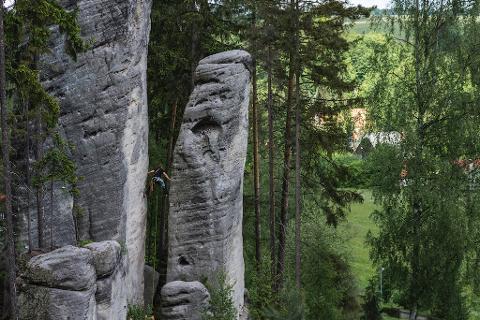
[{"x1": 0, "y1": 1, "x2": 18, "y2": 320}]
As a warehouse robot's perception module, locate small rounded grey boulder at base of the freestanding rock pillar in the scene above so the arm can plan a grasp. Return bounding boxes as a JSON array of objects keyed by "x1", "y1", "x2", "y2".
[{"x1": 162, "y1": 281, "x2": 210, "y2": 320}]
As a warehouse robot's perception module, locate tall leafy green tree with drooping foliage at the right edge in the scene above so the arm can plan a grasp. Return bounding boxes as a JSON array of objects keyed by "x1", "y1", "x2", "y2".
[{"x1": 369, "y1": 0, "x2": 479, "y2": 319}]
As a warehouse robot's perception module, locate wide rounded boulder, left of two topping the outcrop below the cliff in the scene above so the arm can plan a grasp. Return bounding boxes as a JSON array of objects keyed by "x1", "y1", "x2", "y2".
[{"x1": 22, "y1": 246, "x2": 97, "y2": 291}]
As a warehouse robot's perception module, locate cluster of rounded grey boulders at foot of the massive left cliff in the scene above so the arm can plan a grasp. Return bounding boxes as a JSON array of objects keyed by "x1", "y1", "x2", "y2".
[{"x1": 19, "y1": 241, "x2": 127, "y2": 320}]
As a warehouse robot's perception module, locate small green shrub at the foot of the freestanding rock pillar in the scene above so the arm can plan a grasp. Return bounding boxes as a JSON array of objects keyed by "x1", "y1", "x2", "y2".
[{"x1": 202, "y1": 273, "x2": 237, "y2": 320}]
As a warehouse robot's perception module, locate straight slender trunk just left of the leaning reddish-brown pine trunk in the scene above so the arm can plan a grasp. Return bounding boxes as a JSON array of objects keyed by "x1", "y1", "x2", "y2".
[{"x1": 267, "y1": 46, "x2": 276, "y2": 276}]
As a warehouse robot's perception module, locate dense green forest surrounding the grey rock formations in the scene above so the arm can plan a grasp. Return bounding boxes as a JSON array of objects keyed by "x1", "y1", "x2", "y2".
[{"x1": 0, "y1": 0, "x2": 480, "y2": 320}]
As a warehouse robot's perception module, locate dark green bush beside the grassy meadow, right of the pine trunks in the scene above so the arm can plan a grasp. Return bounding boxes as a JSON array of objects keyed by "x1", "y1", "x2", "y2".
[{"x1": 302, "y1": 208, "x2": 360, "y2": 320}]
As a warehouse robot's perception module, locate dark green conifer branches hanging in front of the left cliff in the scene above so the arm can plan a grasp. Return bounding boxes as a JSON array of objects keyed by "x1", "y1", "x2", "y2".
[{"x1": 5, "y1": 0, "x2": 88, "y2": 198}]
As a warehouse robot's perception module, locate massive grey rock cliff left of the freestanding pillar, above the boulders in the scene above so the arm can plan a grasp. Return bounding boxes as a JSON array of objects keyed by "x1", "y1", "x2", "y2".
[{"x1": 19, "y1": 0, "x2": 151, "y2": 306}]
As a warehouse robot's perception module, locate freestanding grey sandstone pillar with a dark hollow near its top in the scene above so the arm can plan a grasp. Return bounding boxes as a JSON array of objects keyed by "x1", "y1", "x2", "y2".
[{"x1": 167, "y1": 50, "x2": 251, "y2": 310}]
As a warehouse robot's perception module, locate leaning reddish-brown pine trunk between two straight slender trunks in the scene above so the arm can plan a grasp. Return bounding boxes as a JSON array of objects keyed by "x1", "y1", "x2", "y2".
[{"x1": 277, "y1": 53, "x2": 295, "y2": 290}]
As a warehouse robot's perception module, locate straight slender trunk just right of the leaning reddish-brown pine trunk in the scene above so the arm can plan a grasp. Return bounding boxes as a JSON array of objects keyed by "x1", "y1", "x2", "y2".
[{"x1": 295, "y1": 69, "x2": 302, "y2": 289}]
